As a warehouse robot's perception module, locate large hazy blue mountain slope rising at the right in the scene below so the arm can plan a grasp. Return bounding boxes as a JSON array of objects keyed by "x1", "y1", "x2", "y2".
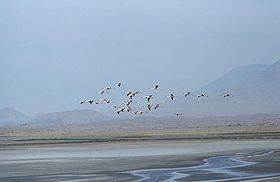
[{"x1": 161, "y1": 61, "x2": 280, "y2": 117}]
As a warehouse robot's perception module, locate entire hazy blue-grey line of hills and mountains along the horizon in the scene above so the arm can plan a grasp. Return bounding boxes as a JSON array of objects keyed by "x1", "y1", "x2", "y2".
[{"x1": 0, "y1": 61, "x2": 280, "y2": 126}]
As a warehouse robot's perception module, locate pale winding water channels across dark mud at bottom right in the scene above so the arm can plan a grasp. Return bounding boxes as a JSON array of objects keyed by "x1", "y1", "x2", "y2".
[{"x1": 128, "y1": 151, "x2": 280, "y2": 182}]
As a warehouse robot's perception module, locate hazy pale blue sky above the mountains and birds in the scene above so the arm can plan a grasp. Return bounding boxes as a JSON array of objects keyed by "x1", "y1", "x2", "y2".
[{"x1": 0, "y1": 0, "x2": 280, "y2": 114}]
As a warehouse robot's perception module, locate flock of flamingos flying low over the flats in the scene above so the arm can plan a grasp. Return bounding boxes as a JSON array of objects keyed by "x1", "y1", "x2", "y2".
[{"x1": 80, "y1": 82, "x2": 233, "y2": 116}]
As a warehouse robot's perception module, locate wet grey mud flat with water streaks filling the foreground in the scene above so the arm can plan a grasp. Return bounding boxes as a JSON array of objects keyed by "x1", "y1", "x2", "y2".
[{"x1": 0, "y1": 140, "x2": 280, "y2": 181}]
